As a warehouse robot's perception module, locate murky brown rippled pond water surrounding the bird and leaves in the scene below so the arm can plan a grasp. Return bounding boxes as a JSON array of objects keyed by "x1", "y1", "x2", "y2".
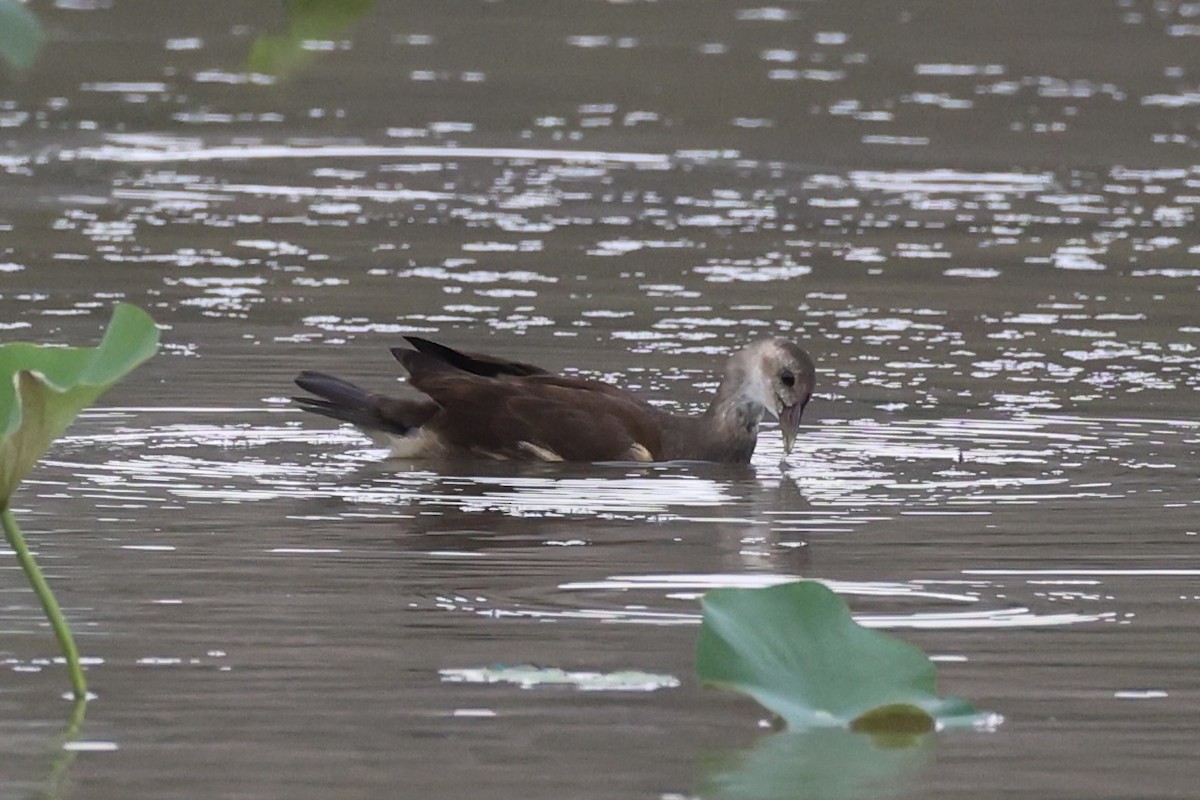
[{"x1": 0, "y1": 0, "x2": 1200, "y2": 800}]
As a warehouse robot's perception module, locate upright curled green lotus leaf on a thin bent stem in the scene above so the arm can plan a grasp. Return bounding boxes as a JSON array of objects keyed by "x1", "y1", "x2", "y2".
[{"x1": 0, "y1": 303, "x2": 158, "y2": 698}]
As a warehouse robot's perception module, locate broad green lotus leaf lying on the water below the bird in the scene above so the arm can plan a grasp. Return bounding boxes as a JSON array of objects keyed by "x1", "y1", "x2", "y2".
[{"x1": 696, "y1": 581, "x2": 995, "y2": 734}]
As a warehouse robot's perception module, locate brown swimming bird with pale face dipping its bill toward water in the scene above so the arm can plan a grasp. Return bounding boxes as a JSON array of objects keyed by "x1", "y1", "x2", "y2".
[{"x1": 293, "y1": 336, "x2": 816, "y2": 464}]
